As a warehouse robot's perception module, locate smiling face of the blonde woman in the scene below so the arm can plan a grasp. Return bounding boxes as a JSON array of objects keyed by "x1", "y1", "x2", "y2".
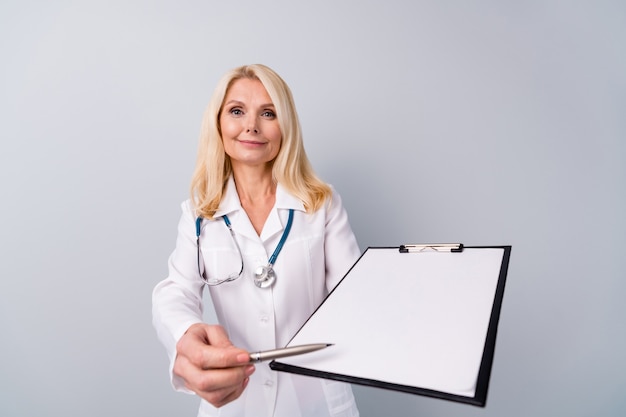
[{"x1": 220, "y1": 78, "x2": 282, "y2": 168}]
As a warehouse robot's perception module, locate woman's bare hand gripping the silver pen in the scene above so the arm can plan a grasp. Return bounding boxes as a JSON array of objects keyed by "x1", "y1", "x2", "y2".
[{"x1": 174, "y1": 323, "x2": 254, "y2": 407}]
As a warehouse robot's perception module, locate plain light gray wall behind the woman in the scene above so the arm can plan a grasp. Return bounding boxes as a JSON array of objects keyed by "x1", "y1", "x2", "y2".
[{"x1": 0, "y1": 0, "x2": 626, "y2": 417}]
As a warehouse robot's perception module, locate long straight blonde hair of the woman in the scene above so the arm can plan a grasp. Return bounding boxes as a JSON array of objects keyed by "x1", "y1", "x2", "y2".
[{"x1": 191, "y1": 64, "x2": 331, "y2": 218}]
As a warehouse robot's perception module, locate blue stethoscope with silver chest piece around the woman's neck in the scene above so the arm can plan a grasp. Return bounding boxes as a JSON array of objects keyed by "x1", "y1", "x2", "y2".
[{"x1": 196, "y1": 209, "x2": 293, "y2": 288}]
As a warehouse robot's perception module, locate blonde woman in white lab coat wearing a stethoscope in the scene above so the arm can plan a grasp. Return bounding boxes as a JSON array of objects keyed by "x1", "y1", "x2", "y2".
[{"x1": 153, "y1": 65, "x2": 360, "y2": 417}]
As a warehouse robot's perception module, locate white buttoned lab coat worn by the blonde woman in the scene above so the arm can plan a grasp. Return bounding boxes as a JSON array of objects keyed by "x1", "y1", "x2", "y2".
[{"x1": 153, "y1": 178, "x2": 360, "y2": 417}]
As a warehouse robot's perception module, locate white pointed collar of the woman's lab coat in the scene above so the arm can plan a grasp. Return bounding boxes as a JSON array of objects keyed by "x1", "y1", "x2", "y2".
[{"x1": 215, "y1": 175, "x2": 305, "y2": 241}]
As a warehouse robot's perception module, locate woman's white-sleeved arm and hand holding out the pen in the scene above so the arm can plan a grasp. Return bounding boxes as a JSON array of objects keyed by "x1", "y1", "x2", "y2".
[{"x1": 152, "y1": 203, "x2": 254, "y2": 407}]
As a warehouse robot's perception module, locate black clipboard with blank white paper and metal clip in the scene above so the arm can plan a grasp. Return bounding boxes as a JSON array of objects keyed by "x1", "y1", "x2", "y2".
[{"x1": 270, "y1": 244, "x2": 511, "y2": 407}]
